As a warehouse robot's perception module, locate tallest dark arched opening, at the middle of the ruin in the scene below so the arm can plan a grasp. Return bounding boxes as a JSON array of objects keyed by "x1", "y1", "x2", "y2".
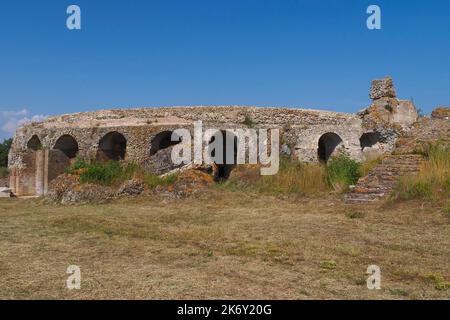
[{"x1": 209, "y1": 130, "x2": 238, "y2": 182}]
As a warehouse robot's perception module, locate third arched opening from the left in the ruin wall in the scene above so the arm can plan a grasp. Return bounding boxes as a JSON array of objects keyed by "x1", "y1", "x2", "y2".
[{"x1": 97, "y1": 131, "x2": 127, "y2": 161}]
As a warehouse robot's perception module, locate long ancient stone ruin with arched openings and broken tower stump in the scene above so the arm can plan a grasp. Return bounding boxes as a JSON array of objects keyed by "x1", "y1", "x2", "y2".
[{"x1": 9, "y1": 78, "x2": 417, "y2": 196}]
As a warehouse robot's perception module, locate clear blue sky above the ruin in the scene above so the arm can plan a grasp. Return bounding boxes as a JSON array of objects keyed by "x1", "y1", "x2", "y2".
[{"x1": 0, "y1": 0, "x2": 450, "y2": 138}]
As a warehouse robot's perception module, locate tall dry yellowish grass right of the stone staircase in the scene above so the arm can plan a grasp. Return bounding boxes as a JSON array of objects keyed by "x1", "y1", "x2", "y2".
[{"x1": 392, "y1": 142, "x2": 450, "y2": 200}]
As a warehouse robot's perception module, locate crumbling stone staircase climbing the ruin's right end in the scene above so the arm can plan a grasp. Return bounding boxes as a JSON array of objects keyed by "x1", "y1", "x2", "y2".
[{"x1": 344, "y1": 154, "x2": 424, "y2": 203}]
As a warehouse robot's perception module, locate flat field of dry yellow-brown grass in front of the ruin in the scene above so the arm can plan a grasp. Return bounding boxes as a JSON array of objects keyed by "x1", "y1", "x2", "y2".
[{"x1": 0, "y1": 190, "x2": 450, "y2": 299}]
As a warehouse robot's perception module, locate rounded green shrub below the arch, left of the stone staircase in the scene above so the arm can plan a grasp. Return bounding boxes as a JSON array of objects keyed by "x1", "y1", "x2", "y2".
[{"x1": 327, "y1": 154, "x2": 360, "y2": 190}]
